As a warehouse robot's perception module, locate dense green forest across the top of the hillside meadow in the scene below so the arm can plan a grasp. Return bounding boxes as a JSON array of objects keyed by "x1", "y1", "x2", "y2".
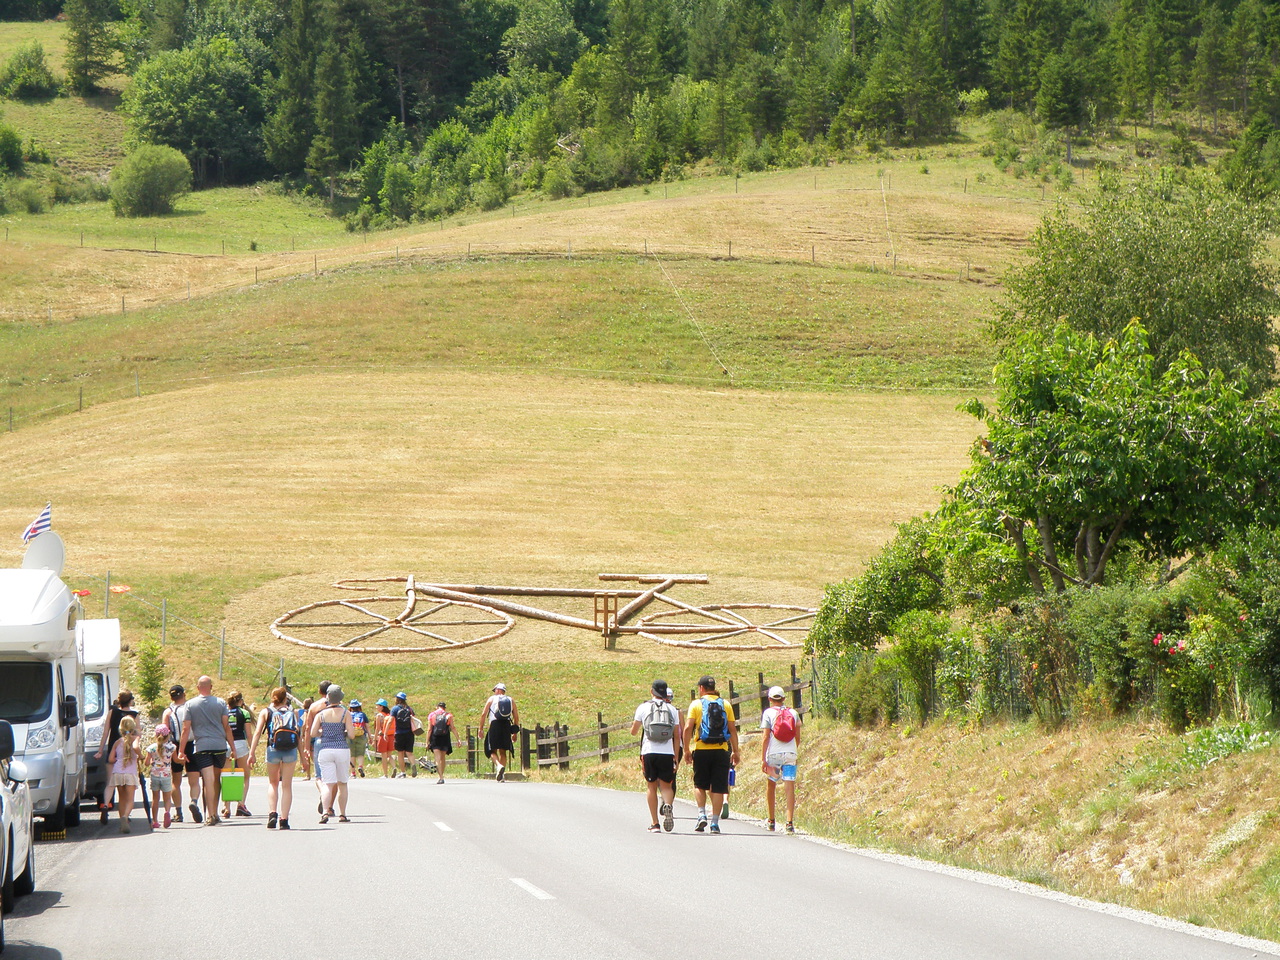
[{"x1": 8, "y1": 0, "x2": 1280, "y2": 221}]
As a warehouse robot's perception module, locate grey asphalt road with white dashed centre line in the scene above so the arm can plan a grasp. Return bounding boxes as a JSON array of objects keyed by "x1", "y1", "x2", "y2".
[{"x1": 5, "y1": 776, "x2": 1280, "y2": 960}]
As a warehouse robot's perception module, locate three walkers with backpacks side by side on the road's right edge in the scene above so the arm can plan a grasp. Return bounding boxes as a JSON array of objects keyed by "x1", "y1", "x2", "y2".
[{"x1": 631, "y1": 676, "x2": 801, "y2": 835}]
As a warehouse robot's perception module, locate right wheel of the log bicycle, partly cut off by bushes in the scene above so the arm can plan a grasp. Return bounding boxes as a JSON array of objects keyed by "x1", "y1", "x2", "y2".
[{"x1": 636, "y1": 596, "x2": 818, "y2": 650}]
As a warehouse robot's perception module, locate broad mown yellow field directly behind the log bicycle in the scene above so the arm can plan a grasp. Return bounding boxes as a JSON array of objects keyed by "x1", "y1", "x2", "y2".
[{"x1": 0, "y1": 371, "x2": 974, "y2": 660}]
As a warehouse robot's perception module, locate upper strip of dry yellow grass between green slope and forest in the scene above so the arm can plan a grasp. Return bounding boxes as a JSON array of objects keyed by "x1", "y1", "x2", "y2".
[{"x1": 0, "y1": 163, "x2": 1047, "y2": 319}]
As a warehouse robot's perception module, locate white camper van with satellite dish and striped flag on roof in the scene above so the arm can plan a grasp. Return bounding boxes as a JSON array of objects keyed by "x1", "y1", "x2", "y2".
[{"x1": 0, "y1": 531, "x2": 84, "y2": 831}]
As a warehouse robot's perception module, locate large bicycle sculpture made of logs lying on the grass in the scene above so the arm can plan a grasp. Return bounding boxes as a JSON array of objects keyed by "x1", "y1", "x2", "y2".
[{"x1": 271, "y1": 573, "x2": 817, "y2": 653}]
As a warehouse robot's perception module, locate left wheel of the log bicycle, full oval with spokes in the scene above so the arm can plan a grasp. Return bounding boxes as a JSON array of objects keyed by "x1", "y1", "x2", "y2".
[{"x1": 271, "y1": 593, "x2": 516, "y2": 653}]
